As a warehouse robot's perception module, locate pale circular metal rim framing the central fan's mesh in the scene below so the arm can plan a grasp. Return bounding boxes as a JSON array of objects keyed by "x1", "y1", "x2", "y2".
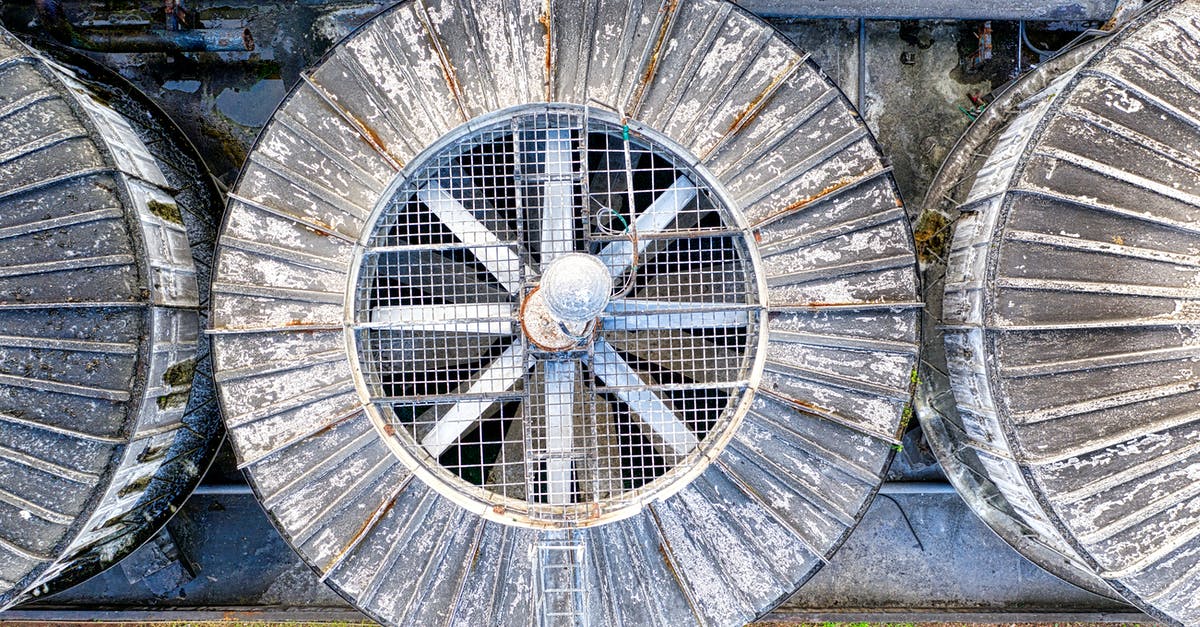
[{"x1": 342, "y1": 102, "x2": 769, "y2": 529}]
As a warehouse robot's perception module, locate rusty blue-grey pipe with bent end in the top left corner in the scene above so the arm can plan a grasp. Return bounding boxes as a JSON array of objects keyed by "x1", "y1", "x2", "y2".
[{"x1": 36, "y1": 0, "x2": 254, "y2": 53}]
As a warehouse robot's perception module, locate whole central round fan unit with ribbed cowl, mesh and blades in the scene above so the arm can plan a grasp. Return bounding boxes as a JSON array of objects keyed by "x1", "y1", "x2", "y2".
[{"x1": 211, "y1": 0, "x2": 919, "y2": 625}]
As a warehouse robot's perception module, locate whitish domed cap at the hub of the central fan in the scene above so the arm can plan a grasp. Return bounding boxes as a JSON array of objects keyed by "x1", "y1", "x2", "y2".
[{"x1": 521, "y1": 252, "x2": 612, "y2": 351}]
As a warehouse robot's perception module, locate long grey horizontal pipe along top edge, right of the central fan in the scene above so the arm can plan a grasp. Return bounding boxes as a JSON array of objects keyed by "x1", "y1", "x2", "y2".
[{"x1": 738, "y1": 0, "x2": 1120, "y2": 22}]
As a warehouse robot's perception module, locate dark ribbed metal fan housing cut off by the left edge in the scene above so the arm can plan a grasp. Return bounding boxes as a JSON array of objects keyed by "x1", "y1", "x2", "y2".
[{"x1": 0, "y1": 31, "x2": 221, "y2": 608}]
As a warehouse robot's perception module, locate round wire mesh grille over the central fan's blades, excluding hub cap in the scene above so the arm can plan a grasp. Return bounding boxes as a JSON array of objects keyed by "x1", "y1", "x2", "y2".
[{"x1": 354, "y1": 106, "x2": 762, "y2": 526}]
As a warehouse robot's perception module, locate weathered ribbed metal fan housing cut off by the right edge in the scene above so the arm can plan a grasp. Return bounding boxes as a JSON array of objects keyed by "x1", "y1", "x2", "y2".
[{"x1": 919, "y1": 2, "x2": 1200, "y2": 625}]
